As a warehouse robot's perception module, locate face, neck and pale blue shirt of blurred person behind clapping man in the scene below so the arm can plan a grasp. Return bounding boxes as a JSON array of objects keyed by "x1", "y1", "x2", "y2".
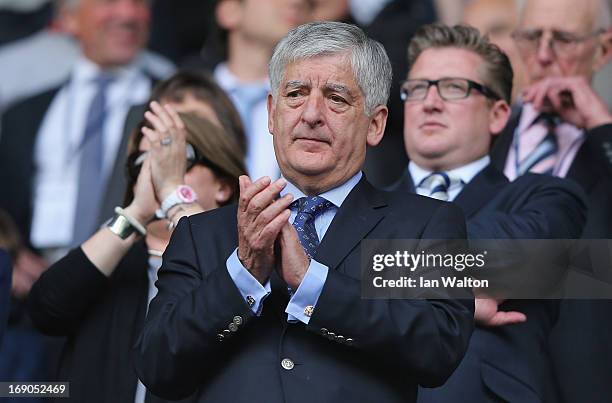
[{"x1": 187, "y1": 0, "x2": 312, "y2": 178}]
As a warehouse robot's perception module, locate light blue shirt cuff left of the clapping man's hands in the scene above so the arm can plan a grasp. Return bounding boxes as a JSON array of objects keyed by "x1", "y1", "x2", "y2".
[{"x1": 225, "y1": 248, "x2": 272, "y2": 316}]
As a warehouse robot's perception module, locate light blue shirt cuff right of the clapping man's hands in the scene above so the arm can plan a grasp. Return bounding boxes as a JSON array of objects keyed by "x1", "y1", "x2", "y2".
[{"x1": 285, "y1": 259, "x2": 329, "y2": 324}]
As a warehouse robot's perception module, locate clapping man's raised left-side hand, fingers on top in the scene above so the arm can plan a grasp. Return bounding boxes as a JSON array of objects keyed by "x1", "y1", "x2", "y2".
[{"x1": 238, "y1": 176, "x2": 293, "y2": 284}]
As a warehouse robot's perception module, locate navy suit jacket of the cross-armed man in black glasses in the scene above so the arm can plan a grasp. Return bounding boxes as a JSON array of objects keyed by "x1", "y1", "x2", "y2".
[{"x1": 397, "y1": 165, "x2": 585, "y2": 403}]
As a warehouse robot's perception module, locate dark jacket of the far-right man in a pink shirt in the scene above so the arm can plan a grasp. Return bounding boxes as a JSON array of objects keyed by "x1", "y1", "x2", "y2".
[{"x1": 491, "y1": 113, "x2": 612, "y2": 403}]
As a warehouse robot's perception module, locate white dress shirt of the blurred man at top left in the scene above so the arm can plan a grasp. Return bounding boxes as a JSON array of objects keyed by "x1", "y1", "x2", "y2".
[{"x1": 30, "y1": 58, "x2": 151, "y2": 249}]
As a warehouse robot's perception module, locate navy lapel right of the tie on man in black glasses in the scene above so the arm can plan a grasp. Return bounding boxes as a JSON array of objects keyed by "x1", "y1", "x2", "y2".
[{"x1": 454, "y1": 165, "x2": 508, "y2": 219}]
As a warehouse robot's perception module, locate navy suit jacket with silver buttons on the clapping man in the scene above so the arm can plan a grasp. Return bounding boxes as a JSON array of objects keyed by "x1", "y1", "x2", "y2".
[{"x1": 134, "y1": 178, "x2": 473, "y2": 403}]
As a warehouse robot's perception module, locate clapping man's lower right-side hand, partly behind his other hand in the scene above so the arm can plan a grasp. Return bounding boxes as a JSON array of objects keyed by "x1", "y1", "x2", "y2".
[{"x1": 276, "y1": 223, "x2": 310, "y2": 290}]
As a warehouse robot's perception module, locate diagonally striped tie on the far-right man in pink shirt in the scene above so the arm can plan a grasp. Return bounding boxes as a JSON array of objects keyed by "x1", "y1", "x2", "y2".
[{"x1": 517, "y1": 113, "x2": 559, "y2": 176}]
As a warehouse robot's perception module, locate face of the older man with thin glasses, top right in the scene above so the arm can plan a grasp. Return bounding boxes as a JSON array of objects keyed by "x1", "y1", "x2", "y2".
[{"x1": 517, "y1": 0, "x2": 610, "y2": 83}]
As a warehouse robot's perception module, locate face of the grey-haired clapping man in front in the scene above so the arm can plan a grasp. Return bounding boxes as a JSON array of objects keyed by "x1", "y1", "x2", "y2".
[{"x1": 268, "y1": 55, "x2": 387, "y2": 194}]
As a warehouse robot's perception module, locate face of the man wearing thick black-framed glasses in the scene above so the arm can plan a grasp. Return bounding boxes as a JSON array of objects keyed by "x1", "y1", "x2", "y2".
[{"x1": 404, "y1": 48, "x2": 509, "y2": 171}]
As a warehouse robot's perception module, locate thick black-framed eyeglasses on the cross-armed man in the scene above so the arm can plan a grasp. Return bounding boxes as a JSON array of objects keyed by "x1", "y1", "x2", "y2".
[{"x1": 400, "y1": 77, "x2": 501, "y2": 102}]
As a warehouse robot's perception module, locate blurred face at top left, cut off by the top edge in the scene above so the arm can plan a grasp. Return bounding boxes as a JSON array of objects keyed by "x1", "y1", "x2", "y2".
[{"x1": 65, "y1": 0, "x2": 150, "y2": 68}]
